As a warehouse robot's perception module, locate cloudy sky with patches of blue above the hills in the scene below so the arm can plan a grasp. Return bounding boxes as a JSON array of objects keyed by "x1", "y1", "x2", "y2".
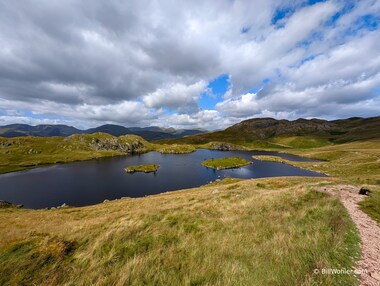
[{"x1": 0, "y1": 0, "x2": 380, "y2": 130}]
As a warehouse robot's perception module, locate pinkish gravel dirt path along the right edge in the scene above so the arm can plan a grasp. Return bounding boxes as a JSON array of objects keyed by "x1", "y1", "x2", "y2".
[{"x1": 320, "y1": 185, "x2": 380, "y2": 286}]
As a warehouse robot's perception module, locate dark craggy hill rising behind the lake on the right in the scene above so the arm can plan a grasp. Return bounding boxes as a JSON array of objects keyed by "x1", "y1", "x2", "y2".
[{"x1": 164, "y1": 117, "x2": 380, "y2": 148}]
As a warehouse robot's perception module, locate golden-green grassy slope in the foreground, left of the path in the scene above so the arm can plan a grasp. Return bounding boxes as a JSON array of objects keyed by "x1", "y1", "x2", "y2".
[{"x1": 0, "y1": 178, "x2": 359, "y2": 285}]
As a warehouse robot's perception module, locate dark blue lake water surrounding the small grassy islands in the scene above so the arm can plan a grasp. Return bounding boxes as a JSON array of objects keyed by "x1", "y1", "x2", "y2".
[{"x1": 0, "y1": 149, "x2": 323, "y2": 208}]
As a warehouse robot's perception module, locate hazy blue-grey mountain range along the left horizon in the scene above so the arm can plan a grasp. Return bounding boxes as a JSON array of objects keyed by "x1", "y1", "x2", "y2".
[{"x1": 0, "y1": 124, "x2": 206, "y2": 141}]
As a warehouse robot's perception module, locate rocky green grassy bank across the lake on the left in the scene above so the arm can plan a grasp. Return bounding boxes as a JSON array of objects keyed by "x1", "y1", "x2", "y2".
[{"x1": 0, "y1": 133, "x2": 195, "y2": 174}]
